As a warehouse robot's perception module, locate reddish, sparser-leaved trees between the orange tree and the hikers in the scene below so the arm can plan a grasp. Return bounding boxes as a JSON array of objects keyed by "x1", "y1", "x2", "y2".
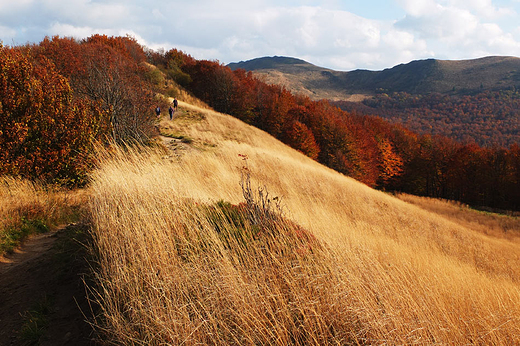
[{"x1": 33, "y1": 35, "x2": 155, "y2": 141}]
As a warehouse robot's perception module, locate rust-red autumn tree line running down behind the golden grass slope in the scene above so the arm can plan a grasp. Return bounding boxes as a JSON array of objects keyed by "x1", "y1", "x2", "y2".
[{"x1": 153, "y1": 49, "x2": 520, "y2": 210}]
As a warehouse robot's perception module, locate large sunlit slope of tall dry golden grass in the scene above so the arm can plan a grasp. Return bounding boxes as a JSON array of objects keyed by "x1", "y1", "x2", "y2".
[{"x1": 90, "y1": 103, "x2": 520, "y2": 345}]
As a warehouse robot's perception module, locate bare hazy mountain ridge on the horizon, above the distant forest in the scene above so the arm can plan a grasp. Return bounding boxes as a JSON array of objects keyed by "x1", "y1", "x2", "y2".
[{"x1": 228, "y1": 56, "x2": 520, "y2": 100}]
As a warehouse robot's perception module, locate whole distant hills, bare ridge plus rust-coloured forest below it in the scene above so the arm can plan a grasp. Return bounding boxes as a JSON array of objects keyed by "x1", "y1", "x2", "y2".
[{"x1": 232, "y1": 57, "x2": 520, "y2": 148}]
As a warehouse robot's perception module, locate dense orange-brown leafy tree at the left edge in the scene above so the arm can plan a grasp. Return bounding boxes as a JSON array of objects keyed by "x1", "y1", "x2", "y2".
[{"x1": 0, "y1": 46, "x2": 106, "y2": 185}]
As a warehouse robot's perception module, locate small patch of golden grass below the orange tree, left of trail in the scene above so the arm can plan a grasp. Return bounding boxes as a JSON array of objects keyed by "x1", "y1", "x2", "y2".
[{"x1": 0, "y1": 177, "x2": 86, "y2": 256}]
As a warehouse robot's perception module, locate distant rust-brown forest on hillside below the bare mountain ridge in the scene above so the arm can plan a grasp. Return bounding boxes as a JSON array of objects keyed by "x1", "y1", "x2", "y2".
[{"x1": 334, "y1": 89, "x2": 520, "y2": 148}]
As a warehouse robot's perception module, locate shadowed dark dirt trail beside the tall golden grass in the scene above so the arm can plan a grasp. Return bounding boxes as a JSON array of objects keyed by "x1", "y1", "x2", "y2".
[{"x1": 0, "y1": 225, "x2": 95, "y2": 346}]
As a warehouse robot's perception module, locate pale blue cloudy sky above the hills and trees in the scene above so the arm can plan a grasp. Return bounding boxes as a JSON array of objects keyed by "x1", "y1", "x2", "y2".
[{"x1": 0, "y1": 0, "x2": 520, "y2": 71}]
